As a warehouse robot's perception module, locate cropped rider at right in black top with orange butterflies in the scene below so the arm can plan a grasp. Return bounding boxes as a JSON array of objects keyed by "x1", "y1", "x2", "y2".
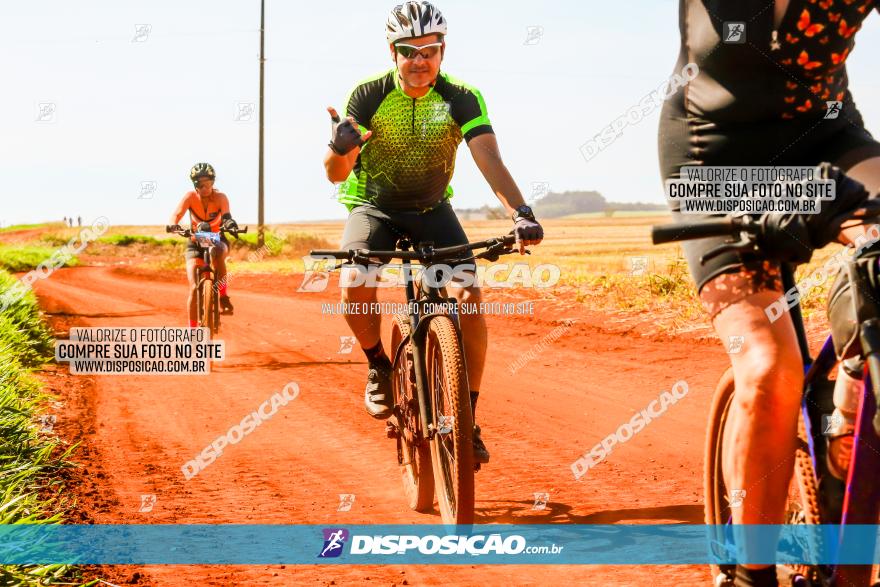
[{"x1": 659, "y1": 0, "x2": 880, "y2": 585}]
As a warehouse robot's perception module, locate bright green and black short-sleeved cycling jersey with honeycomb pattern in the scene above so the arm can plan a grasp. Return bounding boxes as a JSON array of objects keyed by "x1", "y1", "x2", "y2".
[{"x1": 339, "y1": 69, "x2": 493, "y2": 210}]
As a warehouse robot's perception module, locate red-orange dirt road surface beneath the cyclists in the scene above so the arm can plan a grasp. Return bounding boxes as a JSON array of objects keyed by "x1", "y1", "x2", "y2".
[{"x1": 36, "y1": 266, "x2": 728, "y2": 586}]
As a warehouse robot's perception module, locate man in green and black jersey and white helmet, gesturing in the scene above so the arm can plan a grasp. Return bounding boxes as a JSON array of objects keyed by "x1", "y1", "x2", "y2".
[{"x1": 324, "y1": 1, "x2": 543, "y2": 463}]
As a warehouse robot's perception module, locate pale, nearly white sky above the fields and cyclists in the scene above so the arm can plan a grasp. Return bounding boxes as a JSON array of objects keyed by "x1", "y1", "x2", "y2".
[{"x1": 0, "y1": 0, "x2": 880, "y2": 226}]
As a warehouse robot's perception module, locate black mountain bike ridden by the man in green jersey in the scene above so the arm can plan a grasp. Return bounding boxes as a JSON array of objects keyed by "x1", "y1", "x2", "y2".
[{"x1": 310, "y1": 236, "x2": 516, "y2": 524}]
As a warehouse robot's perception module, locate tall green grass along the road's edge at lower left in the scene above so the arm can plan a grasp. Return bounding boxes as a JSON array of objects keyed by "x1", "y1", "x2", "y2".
[{"x1": 0, "y1": 271, "x2": 75, "y2": 586}]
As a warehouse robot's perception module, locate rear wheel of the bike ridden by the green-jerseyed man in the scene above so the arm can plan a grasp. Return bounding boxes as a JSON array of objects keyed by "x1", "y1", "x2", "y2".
[{"x1": 391, "y1": 314, "x2": 434, "y2": 512}]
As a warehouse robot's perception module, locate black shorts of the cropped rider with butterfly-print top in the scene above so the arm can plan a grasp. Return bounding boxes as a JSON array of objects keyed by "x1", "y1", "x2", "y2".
[{"x1": 658, "y1": 99, "x2": 880, "y2": 291}]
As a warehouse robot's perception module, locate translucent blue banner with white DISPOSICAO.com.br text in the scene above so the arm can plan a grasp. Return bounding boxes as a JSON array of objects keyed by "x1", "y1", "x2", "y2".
[{"x1": 0, "y1": 524, "x2": 880, "y2": 565}]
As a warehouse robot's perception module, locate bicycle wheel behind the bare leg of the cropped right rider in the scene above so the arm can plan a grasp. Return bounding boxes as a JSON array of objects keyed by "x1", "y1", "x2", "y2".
[{"x1": 703, "y1": 369, "x2": 822, "y2": 586}]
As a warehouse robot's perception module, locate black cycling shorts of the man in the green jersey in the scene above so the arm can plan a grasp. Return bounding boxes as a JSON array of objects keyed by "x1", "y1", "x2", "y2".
[{"x1": 342, "y1": 201, "x2": 475, "y2": 270}]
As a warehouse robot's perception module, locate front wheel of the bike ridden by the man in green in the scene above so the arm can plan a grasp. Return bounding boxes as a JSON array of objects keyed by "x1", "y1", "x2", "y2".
[{"x1": 425, "y1": 316, "x2": 474, "y2": 524}]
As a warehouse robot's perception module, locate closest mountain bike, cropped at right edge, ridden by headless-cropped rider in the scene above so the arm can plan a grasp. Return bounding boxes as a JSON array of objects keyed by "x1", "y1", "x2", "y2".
[{"x1": 651, "y1": 211, "x2": 880, "y2": 587}]
